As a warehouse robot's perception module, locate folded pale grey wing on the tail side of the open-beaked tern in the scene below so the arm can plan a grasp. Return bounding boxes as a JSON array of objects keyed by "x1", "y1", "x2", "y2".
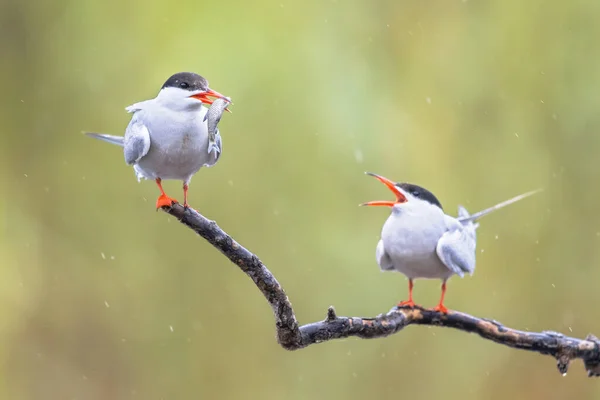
[{"x1": 435, "y1": 229, "x2": 476, "y2": 278}]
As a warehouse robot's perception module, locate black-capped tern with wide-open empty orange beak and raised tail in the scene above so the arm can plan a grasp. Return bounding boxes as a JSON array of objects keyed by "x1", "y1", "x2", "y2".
[{"x1": 361, "y1": 172, "x2": 540, "y2": 313}]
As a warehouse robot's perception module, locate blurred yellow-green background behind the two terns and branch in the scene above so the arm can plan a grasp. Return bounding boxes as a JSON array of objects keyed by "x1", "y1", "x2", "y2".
[{"x1": 0, "y1": 0, "x2": 600, "y2": 400}]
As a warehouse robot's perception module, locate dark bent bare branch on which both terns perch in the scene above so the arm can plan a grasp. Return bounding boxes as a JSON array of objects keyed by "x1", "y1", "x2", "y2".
[{"x1": 163, "y1": 204, "x2": 600, "y2": 376}]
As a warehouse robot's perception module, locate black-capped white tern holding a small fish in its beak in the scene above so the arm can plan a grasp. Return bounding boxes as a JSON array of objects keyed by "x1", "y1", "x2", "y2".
[{"x1": 86, "y1": 72, "x2": 230, "y2": 209}]
